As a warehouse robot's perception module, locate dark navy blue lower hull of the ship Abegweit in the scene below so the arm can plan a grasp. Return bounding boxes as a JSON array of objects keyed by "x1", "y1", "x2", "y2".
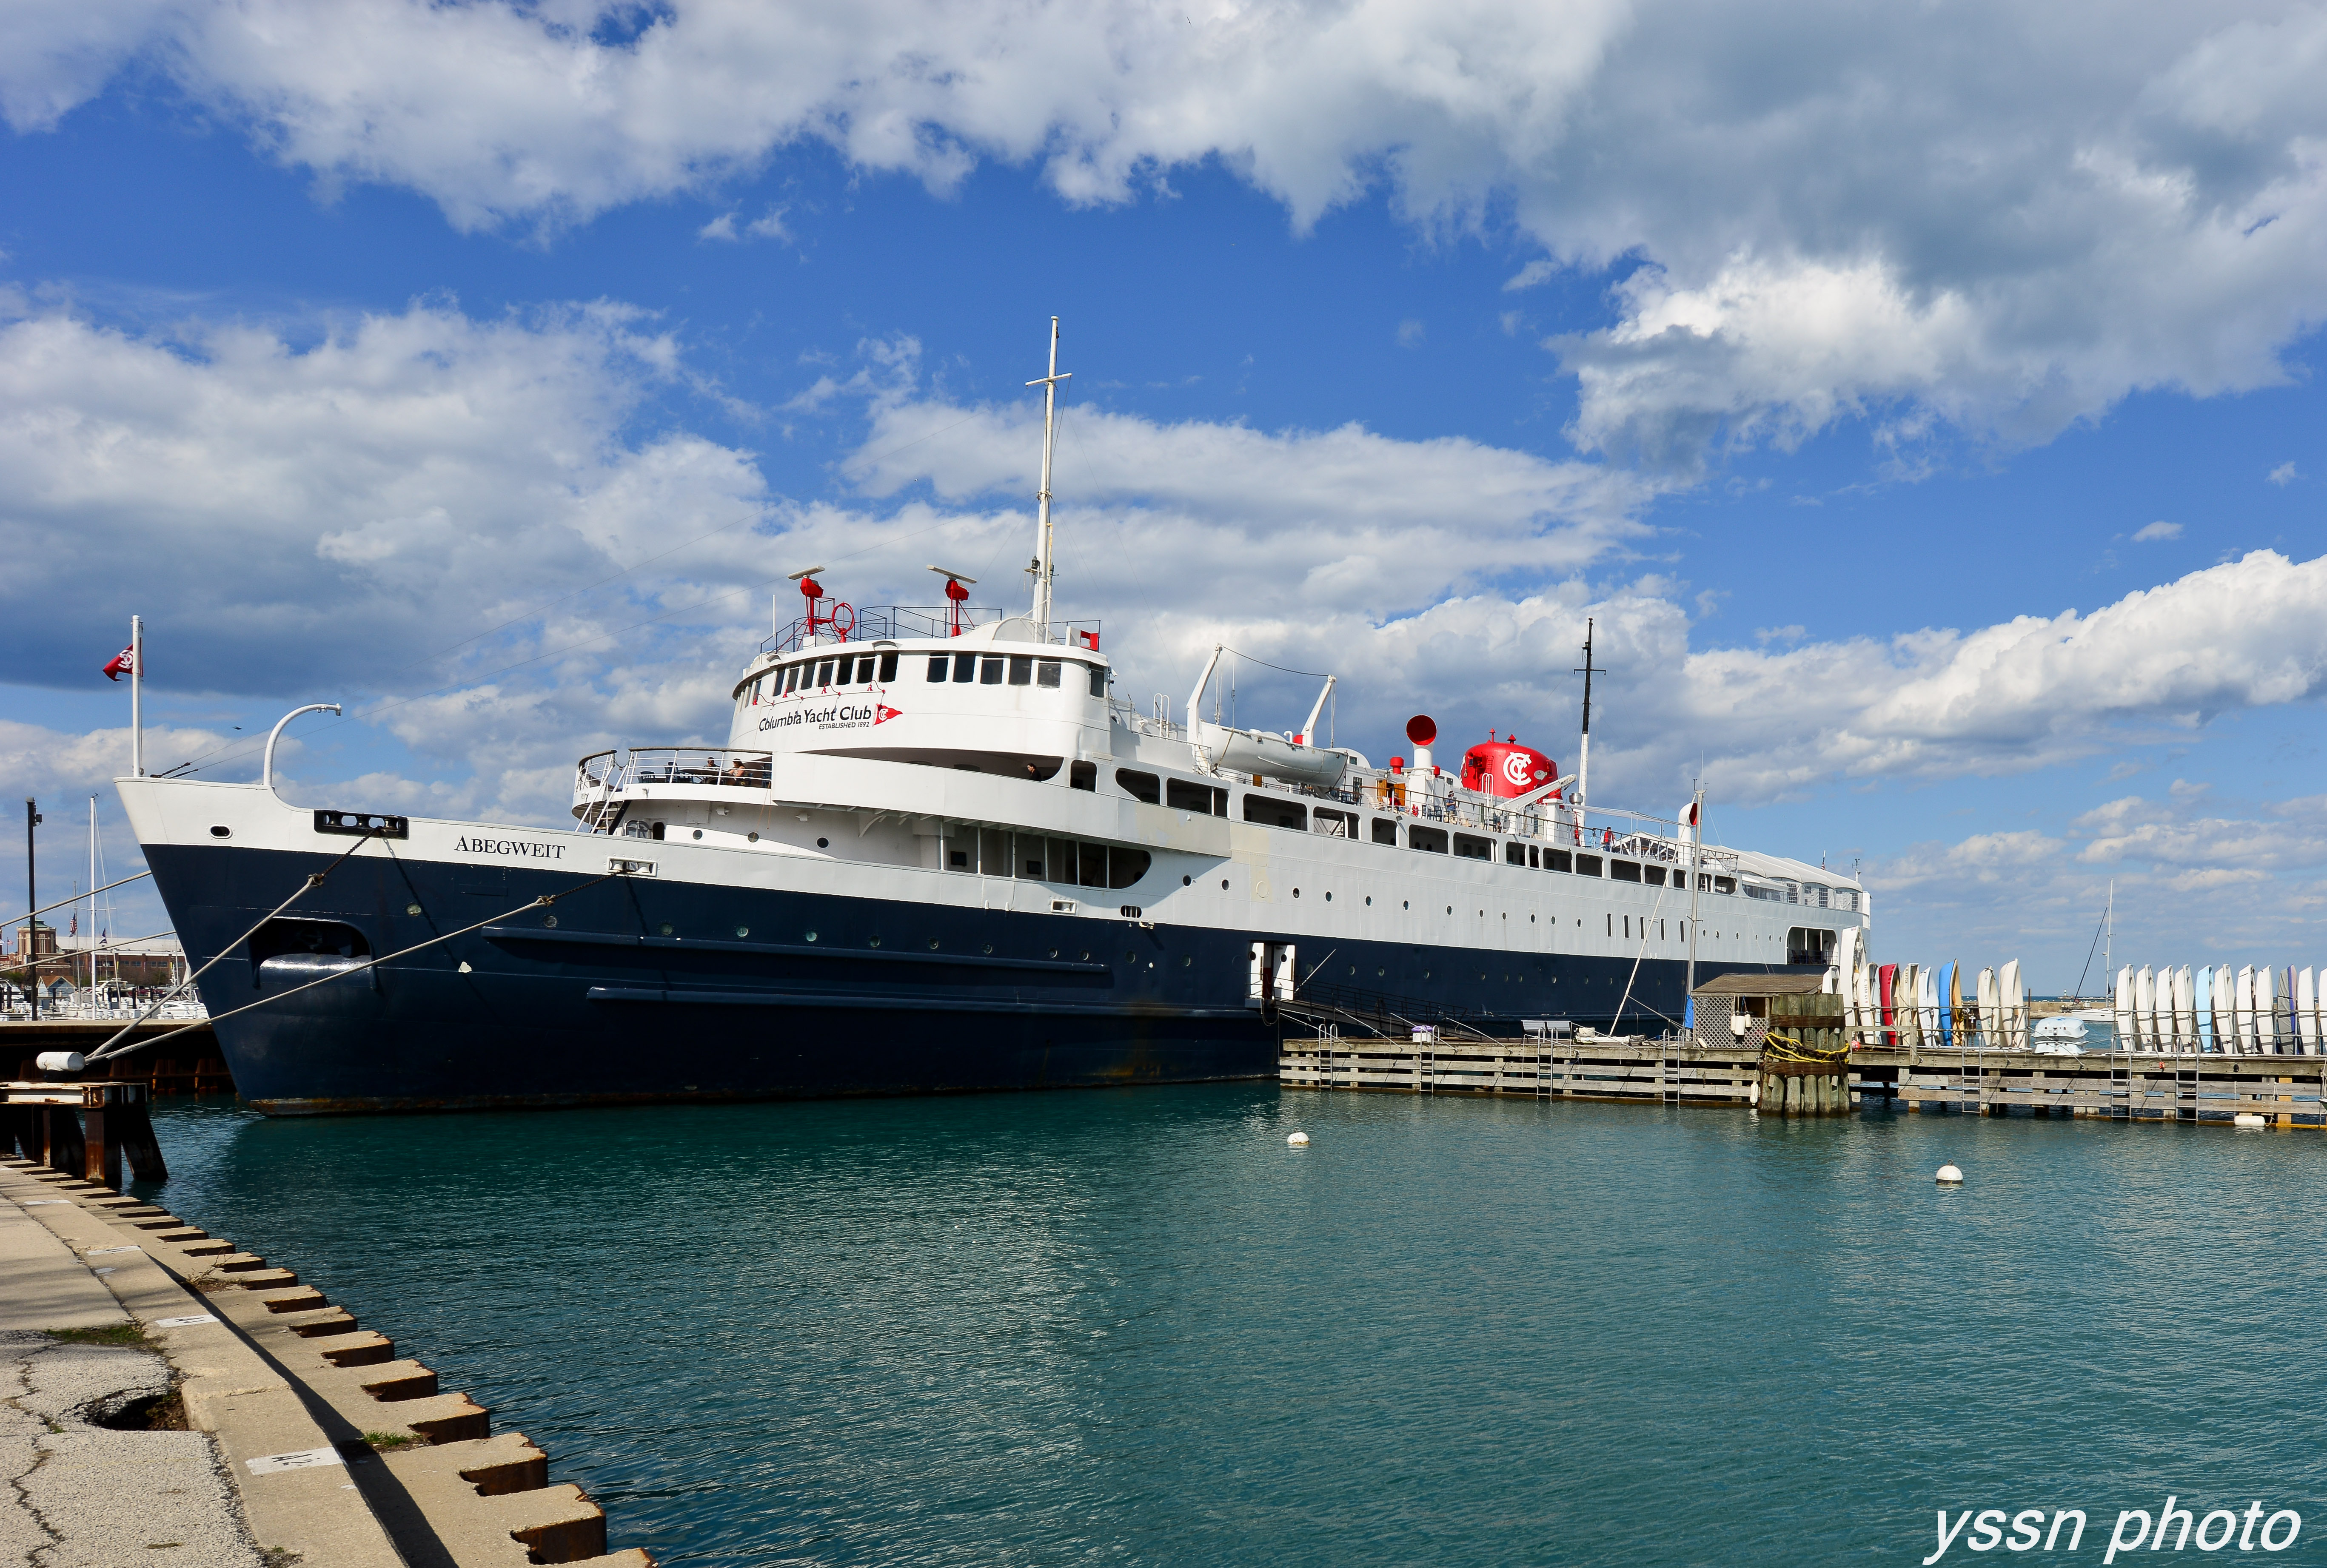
[{"x1": 147, "y1": 845, "x2": 1815, "y2": 1114}]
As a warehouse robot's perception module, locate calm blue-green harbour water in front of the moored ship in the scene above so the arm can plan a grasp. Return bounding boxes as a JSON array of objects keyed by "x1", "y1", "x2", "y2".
[{"x1": 140, "y1": 1084, "x2": 2327, "y2": 1566}]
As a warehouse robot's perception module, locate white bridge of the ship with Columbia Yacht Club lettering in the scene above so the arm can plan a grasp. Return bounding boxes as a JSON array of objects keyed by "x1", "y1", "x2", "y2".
[{"x1": 728, "y1": 607, "x2": 1112, "y2": 780}]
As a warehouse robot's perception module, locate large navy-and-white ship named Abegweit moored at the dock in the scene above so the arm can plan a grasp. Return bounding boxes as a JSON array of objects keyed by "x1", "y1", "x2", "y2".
[{"x1": 117, "y1": 321, "x2": 1871, "y2": 1114}]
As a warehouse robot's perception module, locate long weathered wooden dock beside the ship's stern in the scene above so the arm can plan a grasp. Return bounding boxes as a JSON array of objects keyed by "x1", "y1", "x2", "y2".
[{"x1": 1278, "y1": 1033, "x2": 2327, "y2": 1128}]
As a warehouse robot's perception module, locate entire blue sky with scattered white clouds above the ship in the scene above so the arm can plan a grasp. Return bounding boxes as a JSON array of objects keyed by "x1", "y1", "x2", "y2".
[{"x1": 0, "y1": 0, "x2": 2327, "y2": 986}]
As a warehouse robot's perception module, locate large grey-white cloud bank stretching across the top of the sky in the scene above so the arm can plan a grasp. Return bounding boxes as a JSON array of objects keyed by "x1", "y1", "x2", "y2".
[{"x1": 0, "y1": 0, "x2": 2327, "y2": 465}]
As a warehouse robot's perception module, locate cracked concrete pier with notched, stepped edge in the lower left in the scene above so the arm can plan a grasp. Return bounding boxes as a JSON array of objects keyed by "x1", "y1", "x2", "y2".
[{"x1": 0, "y1": 1161, "x2": 654, "y2": 1568}]
